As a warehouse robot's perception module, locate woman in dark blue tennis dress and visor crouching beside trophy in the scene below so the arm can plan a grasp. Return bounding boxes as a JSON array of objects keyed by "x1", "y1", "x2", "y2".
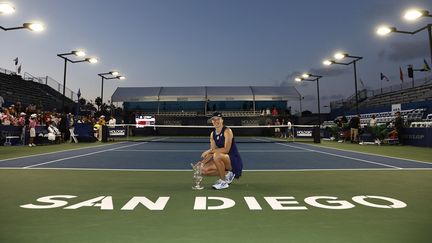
[{"x1": 198, "y1": 112, "x2": 243, "y2": 190}]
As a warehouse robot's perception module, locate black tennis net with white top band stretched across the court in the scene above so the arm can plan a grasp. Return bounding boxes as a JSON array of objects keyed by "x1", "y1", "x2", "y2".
[{"x1": 104, "y1": 124, "x2": 318, "y2": 143}]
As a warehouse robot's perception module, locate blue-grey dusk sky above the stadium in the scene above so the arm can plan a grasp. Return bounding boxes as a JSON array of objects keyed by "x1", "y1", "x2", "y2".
[{"x1": 0, "y1": 0, "x2": 432, "y2": 112}]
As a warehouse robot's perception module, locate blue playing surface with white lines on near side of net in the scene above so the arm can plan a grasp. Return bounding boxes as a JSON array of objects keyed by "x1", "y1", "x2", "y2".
[{"x1": 0, "y1": 142, "x2": 432, "y2": 171}]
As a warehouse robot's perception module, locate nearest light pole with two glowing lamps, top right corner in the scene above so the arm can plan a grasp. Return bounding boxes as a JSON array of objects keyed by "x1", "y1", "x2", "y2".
[{"x1": 376, "y1": 9, "x2": 432, "y2": 63}]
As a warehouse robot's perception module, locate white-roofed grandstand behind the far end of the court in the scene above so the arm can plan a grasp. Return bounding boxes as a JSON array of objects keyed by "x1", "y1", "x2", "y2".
[{"x1": 111, "y1": 86, "x2": 300, "y2": 125}]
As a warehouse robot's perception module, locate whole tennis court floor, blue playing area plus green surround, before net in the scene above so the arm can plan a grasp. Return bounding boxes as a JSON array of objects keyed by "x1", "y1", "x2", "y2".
[{"x1": 0, "y1": 140, "x2": 432, "y2": 242}]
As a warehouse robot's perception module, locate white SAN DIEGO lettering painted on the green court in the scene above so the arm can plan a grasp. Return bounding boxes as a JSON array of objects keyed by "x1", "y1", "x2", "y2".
[{"x1": 20, "y1": 195, "x2": 407, "y2": 211}]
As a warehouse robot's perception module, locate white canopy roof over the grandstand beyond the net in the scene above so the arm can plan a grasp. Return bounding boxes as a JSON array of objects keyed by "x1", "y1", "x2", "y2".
[{"x1": 111, "y1": 86, "x2": 300, "y2": 102}]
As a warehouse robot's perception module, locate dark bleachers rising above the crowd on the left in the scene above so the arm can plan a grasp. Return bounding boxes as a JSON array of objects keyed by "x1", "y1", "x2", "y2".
[{"x1": 0, "y1": 73, "x2": 74, "y2": 110}]
